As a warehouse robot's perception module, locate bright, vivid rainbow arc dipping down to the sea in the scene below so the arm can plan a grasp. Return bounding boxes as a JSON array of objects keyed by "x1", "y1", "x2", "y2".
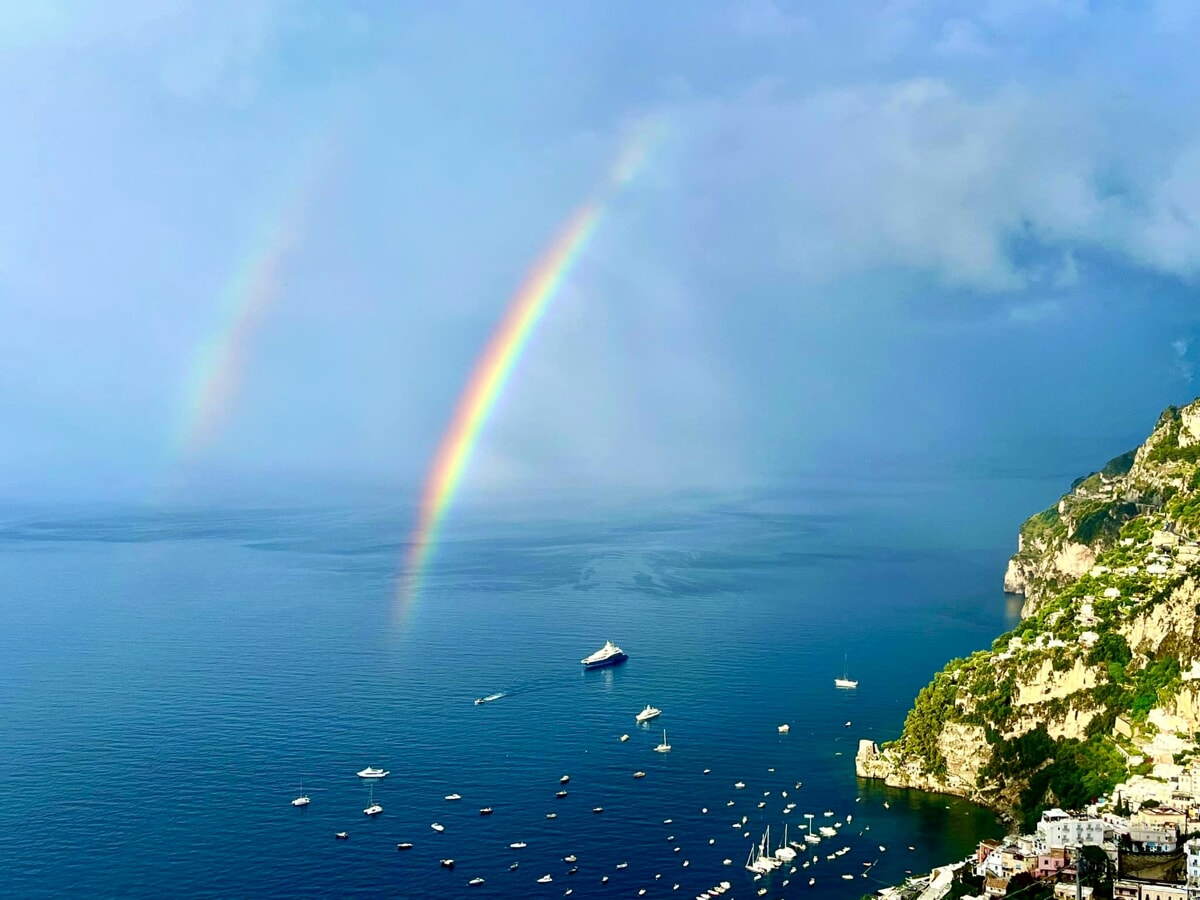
[{"x1": 398, "y1": 118, "x2": 661, "y2": 619}]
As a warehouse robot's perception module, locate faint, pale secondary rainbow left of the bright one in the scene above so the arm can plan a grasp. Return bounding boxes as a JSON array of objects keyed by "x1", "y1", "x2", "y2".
[{"x1": 174, "y1": 134, "x2": 332, "y2": 460}]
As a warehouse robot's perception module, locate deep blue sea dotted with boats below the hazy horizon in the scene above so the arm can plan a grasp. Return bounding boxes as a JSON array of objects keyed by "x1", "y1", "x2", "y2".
[{"x1": 0, "y1": 476, "x2": 1062, "y2": 898}]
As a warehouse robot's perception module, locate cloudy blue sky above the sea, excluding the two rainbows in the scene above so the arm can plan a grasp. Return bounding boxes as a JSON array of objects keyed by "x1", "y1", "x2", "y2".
[{"x1": 0, "y1": 0, "x2": 1200, "y2": 498}]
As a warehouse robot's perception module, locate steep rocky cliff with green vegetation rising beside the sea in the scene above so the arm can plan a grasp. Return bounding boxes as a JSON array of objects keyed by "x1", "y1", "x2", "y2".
[{"x1": 856, "y1": 401, "x2": 1200, "y2": 830}]
